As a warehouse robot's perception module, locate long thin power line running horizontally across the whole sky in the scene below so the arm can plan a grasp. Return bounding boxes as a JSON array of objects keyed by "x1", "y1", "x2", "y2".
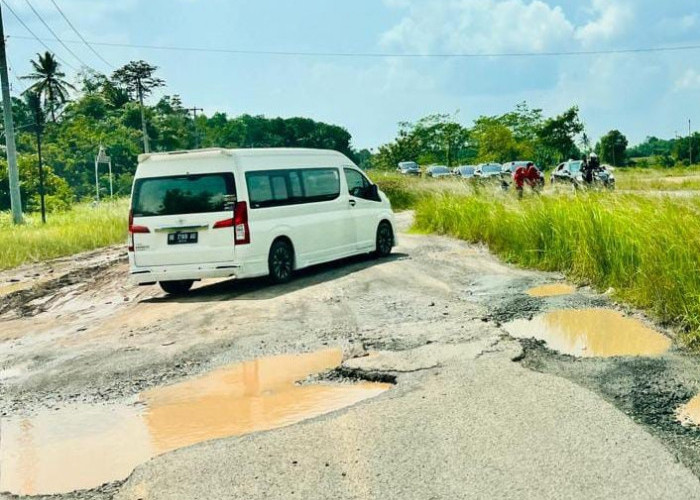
[{"x1": 2, "y1": 33, "x2": 700, "y2": 59}]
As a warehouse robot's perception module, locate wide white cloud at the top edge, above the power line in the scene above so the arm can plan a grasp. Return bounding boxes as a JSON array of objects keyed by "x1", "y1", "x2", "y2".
[{"x1": 381, "y1": 0, "x2": 574, "y2": 53}]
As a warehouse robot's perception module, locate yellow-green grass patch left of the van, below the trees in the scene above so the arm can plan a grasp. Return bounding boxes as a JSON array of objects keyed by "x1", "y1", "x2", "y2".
[{"x1": 0, "y1": 200, "x2": 129, "y2": 269}]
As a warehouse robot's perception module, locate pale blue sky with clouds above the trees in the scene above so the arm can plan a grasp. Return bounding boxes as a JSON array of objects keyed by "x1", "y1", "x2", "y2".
[{"x1": 3, "y1": 0, "x2": 700, "y2": 147}]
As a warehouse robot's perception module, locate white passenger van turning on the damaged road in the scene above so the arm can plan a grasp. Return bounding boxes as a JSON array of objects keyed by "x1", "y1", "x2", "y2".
[{"x1": 129, "y1": 149, "x2": 396, "y2": 294}]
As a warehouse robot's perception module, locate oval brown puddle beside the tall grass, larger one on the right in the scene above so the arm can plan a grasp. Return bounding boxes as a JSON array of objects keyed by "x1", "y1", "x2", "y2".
[{"x1": 505, "y1": 309, "x2": 671, "y2": 357}]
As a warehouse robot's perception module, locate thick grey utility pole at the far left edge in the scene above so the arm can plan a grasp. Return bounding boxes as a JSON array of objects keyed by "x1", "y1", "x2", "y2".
[{"x1": 0, "y1": 4, "x2": 24, "y2": 224}]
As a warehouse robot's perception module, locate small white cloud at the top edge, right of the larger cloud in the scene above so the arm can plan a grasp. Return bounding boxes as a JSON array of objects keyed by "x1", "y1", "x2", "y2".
[{"x1": 576, "y1": 0, "x2": 635, "y2": 46}]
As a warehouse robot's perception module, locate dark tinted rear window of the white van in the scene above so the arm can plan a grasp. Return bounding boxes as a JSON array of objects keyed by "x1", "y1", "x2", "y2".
[{"x1": 131, "y1": 173, "x2": 236, "y2": 217}]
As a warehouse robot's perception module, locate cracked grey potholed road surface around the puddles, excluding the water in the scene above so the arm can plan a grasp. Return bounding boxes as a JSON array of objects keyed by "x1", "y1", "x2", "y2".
[{"x1": 0, "y1": 213, "x2": 700, "y2": 500}]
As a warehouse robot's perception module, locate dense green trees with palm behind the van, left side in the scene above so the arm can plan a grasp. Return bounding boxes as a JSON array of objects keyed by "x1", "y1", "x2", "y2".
[{"x1": 0, "y1": 52, "x2": 360, "y2": 211}]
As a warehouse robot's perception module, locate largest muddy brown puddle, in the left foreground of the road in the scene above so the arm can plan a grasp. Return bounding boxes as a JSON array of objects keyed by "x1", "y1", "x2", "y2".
[{"x1": 0, "y1": 350, "x2": 390, "y2": 495}]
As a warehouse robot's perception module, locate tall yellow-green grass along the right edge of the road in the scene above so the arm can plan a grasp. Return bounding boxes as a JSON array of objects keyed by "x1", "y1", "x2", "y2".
[{"x1": 416, "y1": 194, "x2": 700, "y2": 348}]
